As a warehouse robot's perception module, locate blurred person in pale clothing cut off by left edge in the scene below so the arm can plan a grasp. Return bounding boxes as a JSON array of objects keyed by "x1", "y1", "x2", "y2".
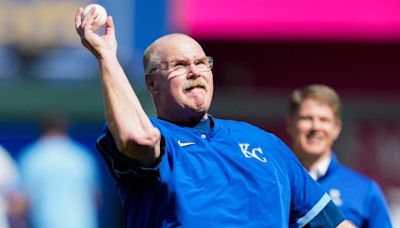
[{"x1": 0, "y1": 146, "x2": 18, "y2": 228}]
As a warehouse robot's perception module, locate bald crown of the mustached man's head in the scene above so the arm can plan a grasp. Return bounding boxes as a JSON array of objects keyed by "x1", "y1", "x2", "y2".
[{"x1": 143, "y1": 33, "x2": 204, "y2": 74}]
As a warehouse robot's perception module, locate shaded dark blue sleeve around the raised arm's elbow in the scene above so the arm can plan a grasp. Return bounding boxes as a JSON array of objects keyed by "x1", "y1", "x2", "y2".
[{"x1": 96, "y1": 126, "x2": 165, "y2": 181}]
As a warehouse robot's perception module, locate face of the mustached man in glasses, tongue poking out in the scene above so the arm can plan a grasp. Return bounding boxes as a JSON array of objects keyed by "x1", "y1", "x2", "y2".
[{"x1": 147, "y1": 37, "x2": 213, "y2": 122}]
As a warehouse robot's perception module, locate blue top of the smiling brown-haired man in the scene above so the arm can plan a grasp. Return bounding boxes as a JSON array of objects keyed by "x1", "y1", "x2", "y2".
[{"x1": 318, "y1": 153, "x2": 392, "y2": 228}]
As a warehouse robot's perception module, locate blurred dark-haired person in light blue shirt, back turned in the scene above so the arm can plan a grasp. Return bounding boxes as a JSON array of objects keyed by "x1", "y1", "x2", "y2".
[{"x1": 20, "y1": 114, "x2": 100, "y2": 228}]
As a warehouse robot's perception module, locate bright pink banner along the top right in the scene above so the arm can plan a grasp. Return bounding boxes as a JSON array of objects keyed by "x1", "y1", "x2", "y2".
[{"x1": 170, "y1": 0, "x2": 400, "y2": 41}]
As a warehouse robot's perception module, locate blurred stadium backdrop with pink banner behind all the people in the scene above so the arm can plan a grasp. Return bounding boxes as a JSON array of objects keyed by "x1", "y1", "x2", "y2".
[{"x1": 0, "y1": 0, "x2": 400, "y2": 227}]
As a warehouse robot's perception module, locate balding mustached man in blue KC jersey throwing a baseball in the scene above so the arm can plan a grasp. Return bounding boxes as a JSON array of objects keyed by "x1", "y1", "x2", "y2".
[{"x1": 75, "y1": 8, "x2": 354, "y2": 227}]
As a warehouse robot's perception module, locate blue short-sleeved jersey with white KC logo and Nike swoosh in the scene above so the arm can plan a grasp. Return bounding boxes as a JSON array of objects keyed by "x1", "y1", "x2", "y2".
[{"x1": 97, "y1": 116, "x2": 337, "y2": 227}]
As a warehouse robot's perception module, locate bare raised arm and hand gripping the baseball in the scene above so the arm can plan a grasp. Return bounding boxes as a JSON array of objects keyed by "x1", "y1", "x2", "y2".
[{"x1": 75, "y1": 8, "x2": 161, "y2": 166}]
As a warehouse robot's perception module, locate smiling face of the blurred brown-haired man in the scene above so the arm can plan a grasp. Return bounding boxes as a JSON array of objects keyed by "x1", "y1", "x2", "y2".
[{"x1": 288, "y1": 98, "x2": 341, "y2": 159}]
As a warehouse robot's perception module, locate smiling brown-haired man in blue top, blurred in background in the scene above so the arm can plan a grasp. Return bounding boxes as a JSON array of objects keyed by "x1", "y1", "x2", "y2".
[{"x1": 287, "y1": 84, "x2": 392, "y2": 227}]
